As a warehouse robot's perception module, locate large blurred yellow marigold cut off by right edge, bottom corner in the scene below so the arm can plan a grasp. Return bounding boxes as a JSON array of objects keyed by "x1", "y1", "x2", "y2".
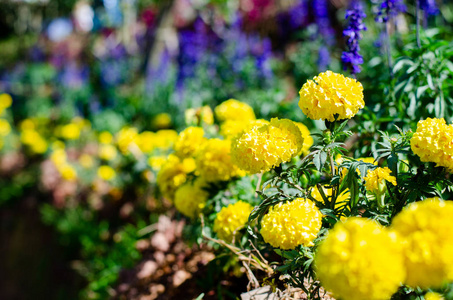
[{"x1": 391, "y1": 199, "x2": 453, "y2": 288}]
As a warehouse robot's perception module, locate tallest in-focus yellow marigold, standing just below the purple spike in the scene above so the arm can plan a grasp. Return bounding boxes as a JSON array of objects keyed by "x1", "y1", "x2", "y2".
[{"x1": 299, "y1": 71, "x2": 365, "y2": 122}]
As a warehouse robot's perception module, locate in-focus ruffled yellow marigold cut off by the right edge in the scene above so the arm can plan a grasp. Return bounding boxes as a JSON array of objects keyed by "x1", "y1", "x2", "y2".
[{"x1": 411, "y1": 118, "x2": 453, "y2": 173}]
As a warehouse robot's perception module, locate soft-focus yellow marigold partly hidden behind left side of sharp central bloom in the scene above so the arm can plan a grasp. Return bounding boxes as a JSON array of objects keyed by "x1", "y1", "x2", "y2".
[{"x1": 195, "y1": 139, "x2": 245, "y2": 182}]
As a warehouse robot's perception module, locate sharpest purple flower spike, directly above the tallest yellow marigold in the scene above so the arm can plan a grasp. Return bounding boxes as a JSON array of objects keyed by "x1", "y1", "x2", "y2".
[{"x1": 341, "y1": 1, "x2": 367, "y2": 74}]
